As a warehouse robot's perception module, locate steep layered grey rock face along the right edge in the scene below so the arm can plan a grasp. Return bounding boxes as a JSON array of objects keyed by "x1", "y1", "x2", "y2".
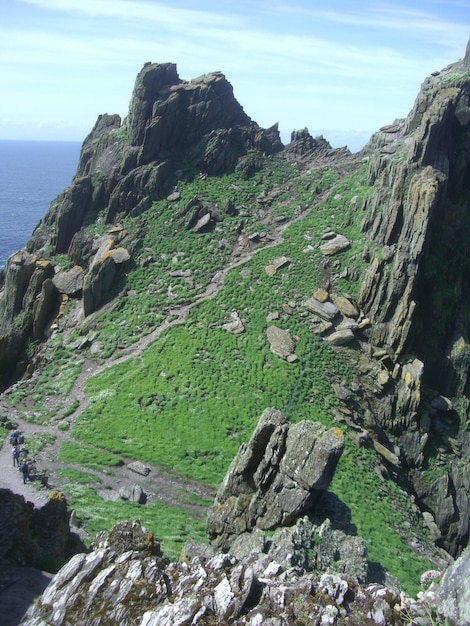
[{"x1": 359, "y1": 50, "x2": 470, "y2": 554}]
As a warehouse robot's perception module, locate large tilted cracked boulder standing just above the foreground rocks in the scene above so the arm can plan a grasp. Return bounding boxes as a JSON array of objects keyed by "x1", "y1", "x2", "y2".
[{"x1": 207, "y1": 408, "x2": 344, "y2": 550}]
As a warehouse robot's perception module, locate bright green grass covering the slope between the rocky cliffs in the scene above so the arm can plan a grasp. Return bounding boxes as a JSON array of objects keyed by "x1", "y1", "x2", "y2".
[{"x1": 4, "y1": 155, "x2": 436, "y2": 591}]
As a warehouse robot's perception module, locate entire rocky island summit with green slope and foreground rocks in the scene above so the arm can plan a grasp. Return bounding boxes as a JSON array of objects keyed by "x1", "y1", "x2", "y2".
[{"x1": 0, "y1": 46, "x2": 470, "y2": 626}]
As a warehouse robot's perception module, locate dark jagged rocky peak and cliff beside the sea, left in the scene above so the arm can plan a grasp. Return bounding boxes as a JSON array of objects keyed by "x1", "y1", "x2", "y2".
[{"x1": 0, "y1": 63, "x2": 282, "y2": 387}]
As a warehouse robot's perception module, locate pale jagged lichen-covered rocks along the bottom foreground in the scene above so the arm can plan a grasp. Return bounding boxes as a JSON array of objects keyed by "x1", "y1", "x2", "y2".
[{"x1": 22, "y1": 520, "x2": 470, "y2": 626}]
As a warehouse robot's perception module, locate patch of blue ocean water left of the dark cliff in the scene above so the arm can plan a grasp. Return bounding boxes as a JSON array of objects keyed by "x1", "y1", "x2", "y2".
[{"x1": 0, "y1": 141, "x2": 81, "y2": 268}]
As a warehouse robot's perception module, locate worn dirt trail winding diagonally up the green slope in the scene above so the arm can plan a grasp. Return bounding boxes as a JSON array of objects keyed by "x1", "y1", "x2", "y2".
[{"x1": 0, "y1": 224, "x2": 287, "y2": 516}]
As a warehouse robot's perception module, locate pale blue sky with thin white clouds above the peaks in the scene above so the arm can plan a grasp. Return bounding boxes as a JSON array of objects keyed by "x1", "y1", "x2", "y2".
[{"x1": 0, "y1": 0, "x2": 470, "y2": 149}]
